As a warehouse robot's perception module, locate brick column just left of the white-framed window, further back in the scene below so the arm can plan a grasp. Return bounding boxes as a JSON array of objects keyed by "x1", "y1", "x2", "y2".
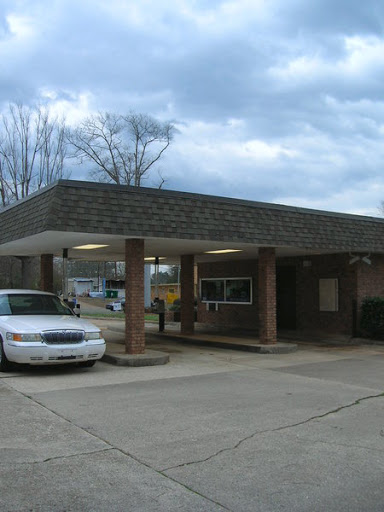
[{"x1": 180, "y1": 255, "x2": 195, "y2": 334}]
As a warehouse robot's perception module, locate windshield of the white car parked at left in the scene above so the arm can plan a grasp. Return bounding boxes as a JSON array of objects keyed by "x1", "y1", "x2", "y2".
[{"x1": 0, "y1": 293, "x2": 73, "y2": 316}]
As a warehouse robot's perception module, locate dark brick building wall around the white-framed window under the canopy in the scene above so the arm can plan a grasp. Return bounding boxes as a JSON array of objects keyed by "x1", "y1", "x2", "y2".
[{"x1": 198, "y1": 254, "x2": 384, "y2": 335}]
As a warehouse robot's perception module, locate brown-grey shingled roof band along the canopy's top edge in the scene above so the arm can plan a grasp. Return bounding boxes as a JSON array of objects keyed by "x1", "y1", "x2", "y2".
[{"x1": 0, "y1": 180, "x2": 384, "y2": 252}]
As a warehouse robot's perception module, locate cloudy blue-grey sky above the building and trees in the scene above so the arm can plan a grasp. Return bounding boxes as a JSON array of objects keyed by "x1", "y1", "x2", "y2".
[{"x1": 0, "y1": 0, "x2": 384, "y2": 216}]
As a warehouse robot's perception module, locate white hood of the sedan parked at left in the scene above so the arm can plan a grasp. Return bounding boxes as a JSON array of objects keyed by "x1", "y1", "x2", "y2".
[{"x1": 0, "y1": 315, "x2": 100, "y2": 332}]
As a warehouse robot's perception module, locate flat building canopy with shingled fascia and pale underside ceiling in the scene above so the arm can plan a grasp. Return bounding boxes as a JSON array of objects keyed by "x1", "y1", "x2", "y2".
[{"x1": 0, "y1": 180, "x2": 384, "y2": 264}]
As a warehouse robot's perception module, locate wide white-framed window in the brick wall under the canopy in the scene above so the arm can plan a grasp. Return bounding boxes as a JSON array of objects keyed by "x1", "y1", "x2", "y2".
[{"x1": 200, "y1": 277, "x2": 252, "y2": 304}]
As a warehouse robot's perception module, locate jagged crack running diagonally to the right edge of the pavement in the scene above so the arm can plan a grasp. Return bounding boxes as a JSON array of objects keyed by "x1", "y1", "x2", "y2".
[{"x1": 161, "y1": 392, "x2": 384, "y2": 472}]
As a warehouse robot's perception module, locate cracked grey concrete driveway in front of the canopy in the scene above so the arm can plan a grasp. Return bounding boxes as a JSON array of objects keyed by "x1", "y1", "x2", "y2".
[{"x1": 0, "y1": 333, "x2": 384, "y2": 512}]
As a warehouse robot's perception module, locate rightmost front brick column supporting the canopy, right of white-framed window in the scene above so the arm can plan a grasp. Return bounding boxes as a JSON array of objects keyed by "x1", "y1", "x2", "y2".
[{"x1": 259, "y1": 247, "x2": 277, "y2": 344}]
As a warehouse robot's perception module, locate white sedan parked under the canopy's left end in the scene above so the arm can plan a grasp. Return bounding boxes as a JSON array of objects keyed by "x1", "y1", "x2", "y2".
[{"x1": 0, "y1": 290, "x2": 105, "y2": 372}]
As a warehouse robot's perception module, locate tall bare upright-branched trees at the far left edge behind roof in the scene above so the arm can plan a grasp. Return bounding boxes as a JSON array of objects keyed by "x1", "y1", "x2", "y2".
[{"x1": 0, "y1": 104, "x2": 66, "y2": 206}]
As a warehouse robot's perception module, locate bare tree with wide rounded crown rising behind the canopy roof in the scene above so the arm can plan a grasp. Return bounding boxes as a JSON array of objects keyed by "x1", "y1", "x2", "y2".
[{"x1": 67, "y1": 112, "x2": 174, "y2": 187}]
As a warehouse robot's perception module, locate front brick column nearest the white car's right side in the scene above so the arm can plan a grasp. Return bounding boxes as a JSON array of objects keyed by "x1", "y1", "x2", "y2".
[{"x1": 125, "y1": 239, "x2": 145, "y2": 354}]
